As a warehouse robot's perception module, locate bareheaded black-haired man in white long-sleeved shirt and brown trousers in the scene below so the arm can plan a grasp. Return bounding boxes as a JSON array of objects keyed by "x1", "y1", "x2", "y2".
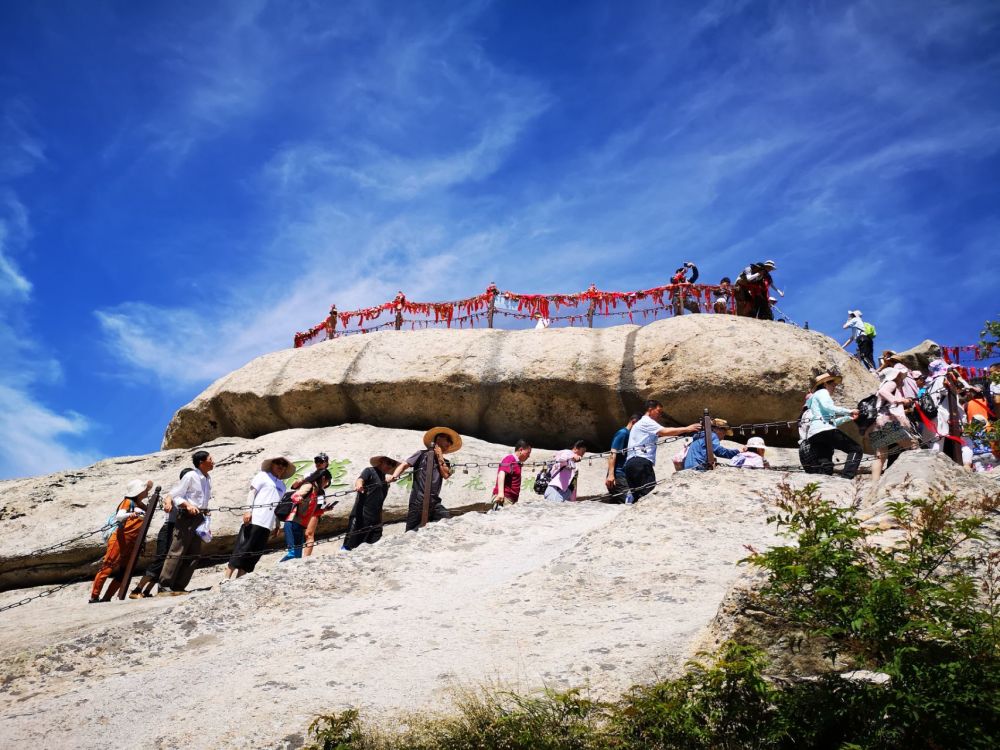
[{"x1": 157, "y1": 451, "x2": 215, "y2": 596}]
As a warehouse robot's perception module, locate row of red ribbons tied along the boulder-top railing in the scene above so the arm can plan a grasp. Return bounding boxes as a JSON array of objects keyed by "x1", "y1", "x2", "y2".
[{"x1": 295, "y1": 284, "x2": 733, "y2": 347}]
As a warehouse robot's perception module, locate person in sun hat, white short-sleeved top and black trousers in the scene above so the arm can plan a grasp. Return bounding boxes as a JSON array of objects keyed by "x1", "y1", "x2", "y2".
[{"x1": 226, "y1": 456, "x2": 292, "y2": 581}]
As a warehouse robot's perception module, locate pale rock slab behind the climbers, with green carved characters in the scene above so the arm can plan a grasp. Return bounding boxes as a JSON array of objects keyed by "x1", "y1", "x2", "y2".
[{"x1": 0, "y1": 425, "x2": 580, "y2": 590}]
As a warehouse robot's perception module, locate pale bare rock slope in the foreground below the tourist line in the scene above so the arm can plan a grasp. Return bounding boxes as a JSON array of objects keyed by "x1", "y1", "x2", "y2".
[{"x1": 0, "y1": 468, "x2": 857, "y2": 748}]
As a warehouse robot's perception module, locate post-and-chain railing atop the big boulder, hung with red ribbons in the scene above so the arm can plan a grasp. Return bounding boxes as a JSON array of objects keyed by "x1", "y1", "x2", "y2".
[{"x1": 294, "y1": 283, "x2": 736, "y2": 348}]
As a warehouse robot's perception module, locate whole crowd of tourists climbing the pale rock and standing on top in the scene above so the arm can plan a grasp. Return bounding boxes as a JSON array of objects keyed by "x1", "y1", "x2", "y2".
[{"x1": 90, "y1": 318, "x2": 1000, "y2": 603}]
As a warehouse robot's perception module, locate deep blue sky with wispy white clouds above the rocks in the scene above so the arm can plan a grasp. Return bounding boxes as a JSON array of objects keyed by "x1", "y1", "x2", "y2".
[{"x1": 0, "y1": 0, "x2": 1000, "y2": 477}]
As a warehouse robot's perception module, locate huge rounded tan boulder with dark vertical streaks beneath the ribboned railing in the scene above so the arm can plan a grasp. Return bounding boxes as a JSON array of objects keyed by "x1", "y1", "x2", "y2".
[{"x1": 163, "y1": 315, "x2": 877, "y2": 449}]
